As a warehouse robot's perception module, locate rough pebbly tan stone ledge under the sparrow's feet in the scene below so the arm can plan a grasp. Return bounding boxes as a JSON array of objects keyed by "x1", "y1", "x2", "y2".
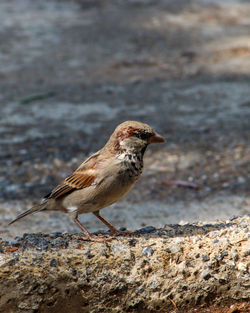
[{"x1": 0, "y1": 215, "x2": 250, "y2": 313}]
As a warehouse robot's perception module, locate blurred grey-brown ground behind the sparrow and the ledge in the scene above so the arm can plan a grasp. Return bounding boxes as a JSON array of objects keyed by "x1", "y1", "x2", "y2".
[{"x1": 0, "y1": 0, "x2": 250, "y2": 238}]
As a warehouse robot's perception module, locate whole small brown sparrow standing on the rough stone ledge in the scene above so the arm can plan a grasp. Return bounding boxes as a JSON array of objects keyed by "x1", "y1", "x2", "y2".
[{"x1": 9, "y1": 121, "x2": 165, "y2": 241}]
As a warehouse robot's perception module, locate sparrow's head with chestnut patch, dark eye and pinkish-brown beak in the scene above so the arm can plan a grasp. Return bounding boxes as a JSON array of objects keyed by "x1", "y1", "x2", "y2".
[{"x1": 108, "y1": 121, "x2": 165, "y2": 152}]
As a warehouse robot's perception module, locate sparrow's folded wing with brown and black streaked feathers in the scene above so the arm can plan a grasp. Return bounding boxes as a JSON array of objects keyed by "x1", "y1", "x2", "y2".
[{"x1": 45, "y1": 152, "x2": 100, "y2": 199}]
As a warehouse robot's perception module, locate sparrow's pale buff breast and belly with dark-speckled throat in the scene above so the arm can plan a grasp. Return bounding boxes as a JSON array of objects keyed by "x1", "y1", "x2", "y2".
[{"x1": 63, "y1": 154, "x2": 143, "y2": 214}]
